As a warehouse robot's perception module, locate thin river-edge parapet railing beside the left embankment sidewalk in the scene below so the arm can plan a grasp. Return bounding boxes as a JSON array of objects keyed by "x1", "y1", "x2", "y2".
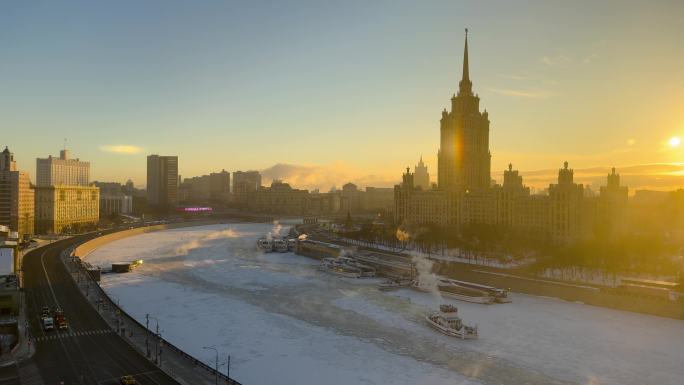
[{"x1": 62, "y1": 247, "x2": 242, "y2": 385}]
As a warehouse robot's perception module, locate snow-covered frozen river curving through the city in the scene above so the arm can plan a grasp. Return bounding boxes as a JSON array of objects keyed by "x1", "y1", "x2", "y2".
[{"x1": 88, "y1": 223, "x2": 684, "y2": 385}]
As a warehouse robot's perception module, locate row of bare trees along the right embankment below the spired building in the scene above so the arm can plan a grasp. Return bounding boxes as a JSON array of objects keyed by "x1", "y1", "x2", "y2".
[{"x1": 340, "y1": 221, "x2": 684, "y2": 280}]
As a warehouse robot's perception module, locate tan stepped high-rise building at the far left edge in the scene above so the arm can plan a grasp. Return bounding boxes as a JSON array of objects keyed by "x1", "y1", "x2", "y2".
[{"x1": 0, "y1": 147, "x2": 35, "y2": 238}]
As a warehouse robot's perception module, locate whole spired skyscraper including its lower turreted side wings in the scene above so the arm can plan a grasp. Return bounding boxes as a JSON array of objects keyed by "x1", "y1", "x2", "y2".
[{"x1": 394, "y1": 31, "x2": 627, "y2": 244}]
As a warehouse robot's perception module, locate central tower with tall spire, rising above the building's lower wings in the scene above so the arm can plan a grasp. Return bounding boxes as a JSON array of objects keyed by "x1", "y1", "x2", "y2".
[{"x1": 437, "y1": 29, "x2": 491, "y2": 191}]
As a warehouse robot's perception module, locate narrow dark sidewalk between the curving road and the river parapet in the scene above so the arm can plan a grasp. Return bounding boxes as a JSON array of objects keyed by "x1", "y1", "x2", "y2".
[{"x1": 62, "y1": 250, "x2": 240, "y2": 385}]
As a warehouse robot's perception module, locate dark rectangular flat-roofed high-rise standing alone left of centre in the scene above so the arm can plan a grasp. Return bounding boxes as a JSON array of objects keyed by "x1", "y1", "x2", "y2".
[{"x1": 147, "y1": 155, "x2": 178, "y2": 210}]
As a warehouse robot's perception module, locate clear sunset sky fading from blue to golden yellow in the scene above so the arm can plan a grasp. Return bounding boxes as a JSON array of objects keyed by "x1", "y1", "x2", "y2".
[{"x1": 0, "y1": 0, "x2": 684, "y2": 190}]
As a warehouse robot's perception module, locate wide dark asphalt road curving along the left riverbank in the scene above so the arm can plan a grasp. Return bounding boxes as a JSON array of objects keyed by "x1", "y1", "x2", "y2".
[{"x1": 23, "y1": 235, "x2": 177, "y2": 385}]
